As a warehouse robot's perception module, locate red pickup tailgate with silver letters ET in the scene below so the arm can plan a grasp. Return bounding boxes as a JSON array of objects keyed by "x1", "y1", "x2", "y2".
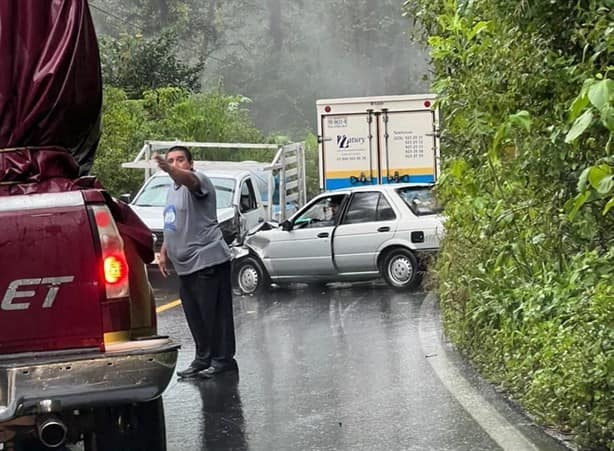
[{"x1": 0, "y1": 191, "x2": 103, "y2": 354}]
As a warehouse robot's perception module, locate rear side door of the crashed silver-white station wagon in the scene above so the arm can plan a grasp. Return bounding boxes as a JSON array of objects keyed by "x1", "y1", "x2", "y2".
[{"x1": 333, "y1": 191, "x2": 397, "y2": 273}]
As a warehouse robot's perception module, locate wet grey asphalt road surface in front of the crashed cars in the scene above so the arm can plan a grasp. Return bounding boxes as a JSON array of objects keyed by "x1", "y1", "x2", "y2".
[{"x1": 152, "y1": 274, "x2": 566, "y2": 451}]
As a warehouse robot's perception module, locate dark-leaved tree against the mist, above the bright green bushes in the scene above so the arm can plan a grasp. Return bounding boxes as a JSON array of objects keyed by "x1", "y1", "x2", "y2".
[{"x1": 100, "y1": 30, "x2": 204, "y2": 99}]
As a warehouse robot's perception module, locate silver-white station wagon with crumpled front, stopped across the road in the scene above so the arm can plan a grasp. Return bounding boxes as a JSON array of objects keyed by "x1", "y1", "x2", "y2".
[{"x1": 233, "y1": 184, "x2": 443, "y2": 294}]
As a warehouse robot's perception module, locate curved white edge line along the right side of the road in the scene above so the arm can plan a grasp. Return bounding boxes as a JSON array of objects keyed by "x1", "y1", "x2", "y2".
[{"x1": 418, "y1": 293, "x2": 539, "y2": 451}]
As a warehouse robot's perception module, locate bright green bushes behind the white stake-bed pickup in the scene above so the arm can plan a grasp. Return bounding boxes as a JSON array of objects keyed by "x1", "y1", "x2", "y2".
[{"x1": 92, "y1": 88, "x2": 264, "y2": 195}]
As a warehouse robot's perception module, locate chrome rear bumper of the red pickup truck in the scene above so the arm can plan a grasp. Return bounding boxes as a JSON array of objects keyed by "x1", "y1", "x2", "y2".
[{"x1": 0, "y1": 338, "x2": 179, "y2": 422}]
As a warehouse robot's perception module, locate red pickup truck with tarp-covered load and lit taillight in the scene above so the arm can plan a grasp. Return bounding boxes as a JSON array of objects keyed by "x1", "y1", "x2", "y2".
[{"x1": 0, "y1": 0, "x2": 179, "y2": 451}]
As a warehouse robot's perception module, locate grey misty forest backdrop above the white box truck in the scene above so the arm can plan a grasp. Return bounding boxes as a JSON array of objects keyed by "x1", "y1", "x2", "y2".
[{"x1": 89, "y1": 0, "x2": 429, "y2": 136}]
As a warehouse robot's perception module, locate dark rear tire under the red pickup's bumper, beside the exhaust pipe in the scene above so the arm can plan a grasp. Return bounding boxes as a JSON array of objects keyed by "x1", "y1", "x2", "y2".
[{"x1": 84, "y1": 398, "x2": 166, "y2": 451}]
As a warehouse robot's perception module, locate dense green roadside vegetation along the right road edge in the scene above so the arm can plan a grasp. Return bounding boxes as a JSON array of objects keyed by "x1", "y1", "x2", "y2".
[{"x1": 404, "y1": 0, "x2": 614, "y2": 450}]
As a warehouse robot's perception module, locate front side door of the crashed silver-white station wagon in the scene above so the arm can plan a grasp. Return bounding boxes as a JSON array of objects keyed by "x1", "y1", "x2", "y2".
[{"x1": 266, "y1": 195, "x2": 345, "y2": 279}]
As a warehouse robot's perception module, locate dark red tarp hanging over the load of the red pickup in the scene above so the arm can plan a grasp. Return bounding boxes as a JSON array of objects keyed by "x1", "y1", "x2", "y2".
[{"x1": 0, "y1": 0, "x2": 102, "y2": 177}]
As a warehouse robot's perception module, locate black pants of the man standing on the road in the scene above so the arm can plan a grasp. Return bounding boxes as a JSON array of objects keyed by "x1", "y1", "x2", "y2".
[{"x1": 179, "y1": 262, "x2": 235, "y2": 367}]
